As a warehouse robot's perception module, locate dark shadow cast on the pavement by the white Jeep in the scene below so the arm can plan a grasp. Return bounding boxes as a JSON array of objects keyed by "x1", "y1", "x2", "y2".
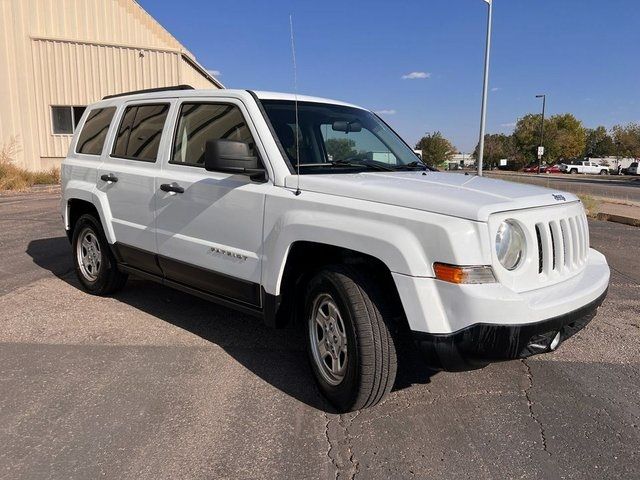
[{"x1": 26, "y1": 237, "x2": 435, "y2": 413}]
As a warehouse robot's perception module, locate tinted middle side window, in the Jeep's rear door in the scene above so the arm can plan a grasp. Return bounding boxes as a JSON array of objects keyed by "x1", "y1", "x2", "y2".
[{"x1": 112, "y1": 103, "x2": 169, "y2": 162}]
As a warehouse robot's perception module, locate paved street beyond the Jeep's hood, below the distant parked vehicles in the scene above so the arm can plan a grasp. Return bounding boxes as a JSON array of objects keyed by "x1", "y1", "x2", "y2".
[{"x1": 485, "y1": 171, "x2": 640, "y2": 202}]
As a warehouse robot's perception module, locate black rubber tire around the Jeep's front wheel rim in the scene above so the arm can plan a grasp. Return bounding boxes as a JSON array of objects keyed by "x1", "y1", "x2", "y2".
[{"x1": 303, "y1": 265, "x2": 397, "y2": 412}]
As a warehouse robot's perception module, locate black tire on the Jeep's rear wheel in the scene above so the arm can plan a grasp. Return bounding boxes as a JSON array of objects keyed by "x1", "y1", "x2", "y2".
[{"x1": 71, "y1": 214, "x2": 128, "y2": 295}]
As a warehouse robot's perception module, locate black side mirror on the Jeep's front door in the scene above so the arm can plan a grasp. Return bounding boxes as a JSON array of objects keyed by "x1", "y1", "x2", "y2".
[{"x1": 204, "y1": 139, "x2": 266, "y2": 181}]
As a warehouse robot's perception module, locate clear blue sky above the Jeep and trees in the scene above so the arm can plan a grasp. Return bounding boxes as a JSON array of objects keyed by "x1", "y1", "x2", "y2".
[{"x1": 140, "y1": 0, "x2": 640, "y2": 152}]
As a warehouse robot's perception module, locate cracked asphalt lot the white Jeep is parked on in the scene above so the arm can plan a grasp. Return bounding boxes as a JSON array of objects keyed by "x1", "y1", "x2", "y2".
[{"x1": 0, "y1": 189, "x2": 640, "y2": 480}]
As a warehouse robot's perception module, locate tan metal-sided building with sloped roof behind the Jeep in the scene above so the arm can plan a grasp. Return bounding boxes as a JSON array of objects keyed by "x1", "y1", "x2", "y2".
[{"x1": 0, "y1": 0, "x2": 223, "y2": 170}]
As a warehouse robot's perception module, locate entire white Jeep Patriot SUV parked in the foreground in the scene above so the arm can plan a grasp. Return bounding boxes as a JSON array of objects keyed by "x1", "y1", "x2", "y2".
[{"x1": 61, "y1": 86, "x2": 609, "y2": 411}]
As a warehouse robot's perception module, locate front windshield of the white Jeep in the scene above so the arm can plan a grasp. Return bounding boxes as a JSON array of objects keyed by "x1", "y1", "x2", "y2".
[{"x1": 262, "y1": 100, "x2": 427, "y2": 174}]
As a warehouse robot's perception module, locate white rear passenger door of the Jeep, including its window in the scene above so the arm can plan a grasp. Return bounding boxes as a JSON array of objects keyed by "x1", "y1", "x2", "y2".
[{"x1": 97, "y1": 99, "x2": 171, "y2": 275}]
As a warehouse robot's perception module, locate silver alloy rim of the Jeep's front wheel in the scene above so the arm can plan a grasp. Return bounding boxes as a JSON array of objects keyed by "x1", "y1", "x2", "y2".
[{"x1": 309, "y1": 294, "x2": 348, "y2": 386}]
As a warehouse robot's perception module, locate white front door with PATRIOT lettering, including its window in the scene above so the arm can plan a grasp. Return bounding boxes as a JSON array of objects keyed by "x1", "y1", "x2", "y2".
[{"x1": 156, "y1": 100, "x2": 267, "y2": 306}]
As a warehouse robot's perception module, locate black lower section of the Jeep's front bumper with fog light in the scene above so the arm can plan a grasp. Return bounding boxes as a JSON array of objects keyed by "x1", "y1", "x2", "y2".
[{"x1": 412, "y1": 290, "x2": 607, "y2": 371}]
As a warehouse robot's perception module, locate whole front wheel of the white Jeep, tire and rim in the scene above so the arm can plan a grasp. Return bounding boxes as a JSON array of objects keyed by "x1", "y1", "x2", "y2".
[{"x1": 304, "y1": 265, "x2": 397, "y2": 412}]
